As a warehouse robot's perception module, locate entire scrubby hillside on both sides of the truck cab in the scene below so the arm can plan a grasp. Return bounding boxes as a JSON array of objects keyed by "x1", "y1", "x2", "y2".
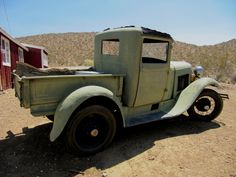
[{"x1": 18, "y1": 33, "x2": 236, "y2": 83}]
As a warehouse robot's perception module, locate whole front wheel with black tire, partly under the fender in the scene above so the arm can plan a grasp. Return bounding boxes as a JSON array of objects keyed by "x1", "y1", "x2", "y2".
[{"x1": 188, "y1": 89, "x2": 223, "y2": 121}]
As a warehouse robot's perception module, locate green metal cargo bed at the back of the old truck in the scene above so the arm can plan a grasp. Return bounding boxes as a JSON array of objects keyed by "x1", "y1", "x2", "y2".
[{"x1": 13, "y1": 65, "x2": 124, "y2": 116}]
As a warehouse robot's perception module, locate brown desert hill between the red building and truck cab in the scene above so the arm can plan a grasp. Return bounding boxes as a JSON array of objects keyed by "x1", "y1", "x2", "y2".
[{"x1": 18, "y1": 33, "x2": 95, "y2": 67}]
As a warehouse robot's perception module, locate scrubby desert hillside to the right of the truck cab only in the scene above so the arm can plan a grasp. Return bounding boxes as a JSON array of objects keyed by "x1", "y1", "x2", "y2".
[{"x1": 172, "y1": 39, "x2": 236, "y2": 83}]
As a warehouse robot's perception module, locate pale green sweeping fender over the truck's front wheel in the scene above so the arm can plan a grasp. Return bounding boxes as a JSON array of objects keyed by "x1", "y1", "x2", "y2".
[{"x1": 167, "y1": 77, "x2": 219, "y2": 117}]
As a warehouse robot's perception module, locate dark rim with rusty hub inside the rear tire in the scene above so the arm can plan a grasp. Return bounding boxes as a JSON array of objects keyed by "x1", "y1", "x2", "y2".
[{"x1": 75, "y1": 113, "x2": 109, "y2": 150}]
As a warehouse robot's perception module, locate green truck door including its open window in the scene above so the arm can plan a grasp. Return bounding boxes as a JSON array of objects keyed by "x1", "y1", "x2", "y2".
[{"x1": 135, "y1": 38, "x2": 169, "y2": 106}]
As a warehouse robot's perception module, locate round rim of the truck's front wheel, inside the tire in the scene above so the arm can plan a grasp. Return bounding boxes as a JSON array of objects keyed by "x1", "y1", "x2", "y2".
[{"x1": 194, "y1": 96, "x2": 216, "y2": 116}]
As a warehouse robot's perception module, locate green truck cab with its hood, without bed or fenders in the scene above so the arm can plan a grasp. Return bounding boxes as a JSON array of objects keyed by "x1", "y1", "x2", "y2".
[{"x1": 94, "y1": 27, "x2": 192, "y2": 107}]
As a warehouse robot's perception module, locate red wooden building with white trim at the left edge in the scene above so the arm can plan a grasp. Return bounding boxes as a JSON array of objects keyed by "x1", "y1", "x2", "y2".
[{"x1": 0, "y1": 27, "x2": 48, "y2": 90}]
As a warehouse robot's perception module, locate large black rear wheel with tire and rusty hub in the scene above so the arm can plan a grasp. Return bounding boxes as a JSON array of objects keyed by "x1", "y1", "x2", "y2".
[{"x1": 65, "y1": 105, "x2": 116, "y2": 156}]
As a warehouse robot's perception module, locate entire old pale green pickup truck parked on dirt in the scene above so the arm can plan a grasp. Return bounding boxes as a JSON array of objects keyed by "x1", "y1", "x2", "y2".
[{"x1": 13, "y1": 26, "x2": 223, "y2": 155}]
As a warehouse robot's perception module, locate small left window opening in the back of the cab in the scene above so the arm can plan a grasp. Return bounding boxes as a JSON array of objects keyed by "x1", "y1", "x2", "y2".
[{"x1": 102, "y1": 39, "x2": 120, "y2": 56}]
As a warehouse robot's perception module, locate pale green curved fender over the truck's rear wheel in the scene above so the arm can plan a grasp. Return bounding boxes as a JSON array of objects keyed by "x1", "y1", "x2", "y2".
[{"x1": 50, "y1": 86, "x2": 121, "y2": 141}]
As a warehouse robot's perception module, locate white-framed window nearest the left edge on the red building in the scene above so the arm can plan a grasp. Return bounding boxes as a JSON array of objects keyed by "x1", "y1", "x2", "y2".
[{"x1": 1, "y1": 36, "x2": 11, "y2": 67}]
